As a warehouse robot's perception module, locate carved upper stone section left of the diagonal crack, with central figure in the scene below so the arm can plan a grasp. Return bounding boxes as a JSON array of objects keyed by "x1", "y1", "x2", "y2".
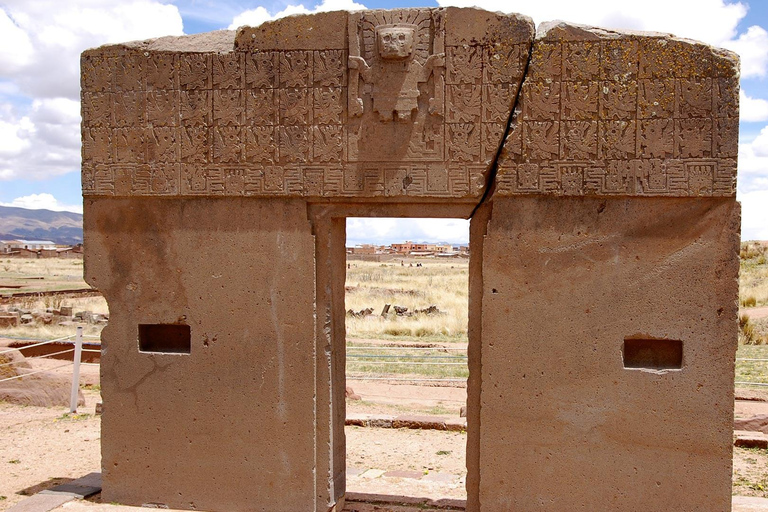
[{"x1": 82, "y1": 8, "x2": 533, "y2": 199}]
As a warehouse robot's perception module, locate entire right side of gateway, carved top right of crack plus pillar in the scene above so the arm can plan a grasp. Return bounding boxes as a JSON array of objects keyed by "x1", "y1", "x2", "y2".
[{"x1": 476, "y1": 19, "x2": 739, "y2": 512}]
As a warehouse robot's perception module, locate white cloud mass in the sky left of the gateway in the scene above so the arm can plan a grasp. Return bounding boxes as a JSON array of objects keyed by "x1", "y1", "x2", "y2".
[{"x1": 0, "y1": 0, "x2": 182, "y2": 181}]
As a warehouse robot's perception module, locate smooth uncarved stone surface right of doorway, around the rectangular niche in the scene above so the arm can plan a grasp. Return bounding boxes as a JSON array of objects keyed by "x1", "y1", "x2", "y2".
[{"x1": 480, "y1": 196, "x2": 739, "y2": 511}]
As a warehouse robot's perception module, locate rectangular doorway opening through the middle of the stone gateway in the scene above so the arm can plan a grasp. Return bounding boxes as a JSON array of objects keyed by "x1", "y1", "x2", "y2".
[{"x1": 344, "y1": 217, "x2": 470, "y2": 500}]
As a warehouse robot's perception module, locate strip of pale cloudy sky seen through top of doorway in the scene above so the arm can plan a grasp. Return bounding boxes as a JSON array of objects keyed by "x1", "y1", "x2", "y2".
[{"x1": 347, "y1": 217, "x2": 469, "y2": 245}]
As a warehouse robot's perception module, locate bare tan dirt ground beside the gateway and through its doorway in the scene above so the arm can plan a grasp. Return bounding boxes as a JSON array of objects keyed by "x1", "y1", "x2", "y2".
[{"x1": 0, "y1": 362, "x2": 768, "y2": 510}]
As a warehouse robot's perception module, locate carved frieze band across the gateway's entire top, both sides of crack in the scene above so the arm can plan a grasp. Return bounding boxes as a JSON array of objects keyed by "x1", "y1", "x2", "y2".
[{"x1": 81, "y1": 8, "x2": 738, "y2": 199}]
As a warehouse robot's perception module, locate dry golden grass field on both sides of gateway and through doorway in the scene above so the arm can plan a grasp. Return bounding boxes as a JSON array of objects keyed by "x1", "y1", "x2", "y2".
[{"x1": 0, "y1": 242, "x2": 768, "y2": 352}]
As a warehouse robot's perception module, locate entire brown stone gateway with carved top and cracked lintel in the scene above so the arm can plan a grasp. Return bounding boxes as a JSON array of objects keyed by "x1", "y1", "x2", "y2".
[{"x1": 81, "y1": 8, "x2": 739, "y2": 512}]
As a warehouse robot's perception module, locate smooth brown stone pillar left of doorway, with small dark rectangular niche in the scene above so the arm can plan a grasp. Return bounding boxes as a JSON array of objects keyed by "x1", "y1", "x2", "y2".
[{"x1": 85, "y1": 197, "x2": 320, "y2": 511}]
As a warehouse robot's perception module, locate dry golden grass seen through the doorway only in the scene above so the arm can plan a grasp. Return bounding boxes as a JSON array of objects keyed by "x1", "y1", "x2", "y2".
[{"x1": 346, "y1": 259, "x2": 469, "y2": 342}]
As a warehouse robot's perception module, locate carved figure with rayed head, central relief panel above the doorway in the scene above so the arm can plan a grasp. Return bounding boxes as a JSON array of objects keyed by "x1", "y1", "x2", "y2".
[{"x1": 348, "y1": 9, "x2": 445, "y2": 161}]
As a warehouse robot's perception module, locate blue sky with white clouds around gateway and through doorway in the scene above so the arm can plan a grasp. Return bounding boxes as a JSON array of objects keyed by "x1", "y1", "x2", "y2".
[{"x1": 0, "y1": 0, "x2": 768, "y2": 243}]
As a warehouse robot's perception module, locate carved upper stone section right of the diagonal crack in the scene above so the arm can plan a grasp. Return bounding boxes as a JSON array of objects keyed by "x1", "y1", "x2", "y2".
[{"x1": 496, "y1": 23, "x2": 739, "y2": 197}]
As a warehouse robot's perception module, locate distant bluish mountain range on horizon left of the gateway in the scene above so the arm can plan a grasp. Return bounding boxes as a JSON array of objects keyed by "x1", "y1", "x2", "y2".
[{"x1": 0, "y1": 206, "x2": 83, "y2": 245}]
